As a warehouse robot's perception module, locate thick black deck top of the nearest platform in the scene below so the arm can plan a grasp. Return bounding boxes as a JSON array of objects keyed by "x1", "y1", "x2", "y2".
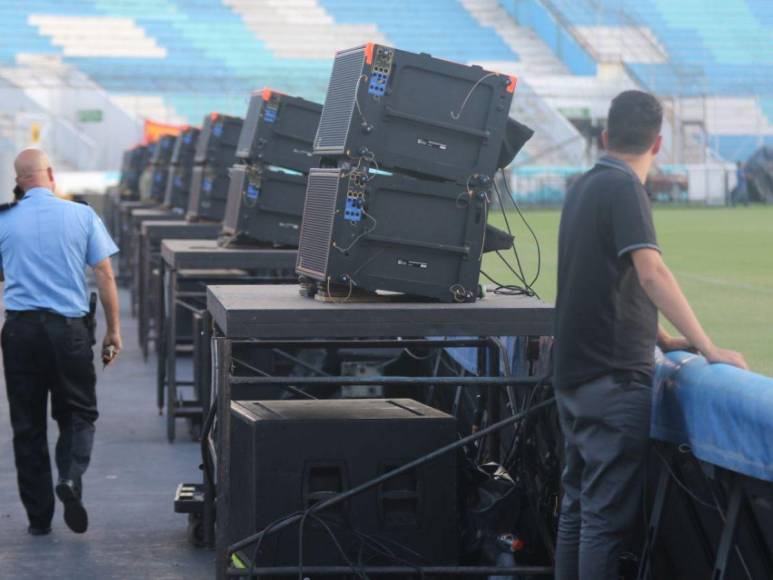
[{"x1": 208, "y1": 286, "x2": 553, "y2": 339}]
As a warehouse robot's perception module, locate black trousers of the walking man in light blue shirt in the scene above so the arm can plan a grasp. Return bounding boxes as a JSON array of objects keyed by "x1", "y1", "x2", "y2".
[{"x1": 2, "y1": 312, "x2": 98, "y2": 527}]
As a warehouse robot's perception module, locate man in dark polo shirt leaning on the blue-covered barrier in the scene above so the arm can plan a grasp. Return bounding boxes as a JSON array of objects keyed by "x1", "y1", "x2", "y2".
[{"x1": 554, "y1": 91, "x2": 746, "y2": 580}]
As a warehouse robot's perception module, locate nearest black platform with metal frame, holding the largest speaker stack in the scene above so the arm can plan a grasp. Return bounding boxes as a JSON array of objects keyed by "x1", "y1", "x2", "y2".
[{"x1": 202, "y1": 285, "x2": 553, "y2": 580}]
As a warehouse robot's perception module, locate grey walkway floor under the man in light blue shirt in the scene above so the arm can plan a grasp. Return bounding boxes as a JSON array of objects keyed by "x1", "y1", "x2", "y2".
[{"x1": 0, "y1": 292, "x2": 214, "y2": 580}]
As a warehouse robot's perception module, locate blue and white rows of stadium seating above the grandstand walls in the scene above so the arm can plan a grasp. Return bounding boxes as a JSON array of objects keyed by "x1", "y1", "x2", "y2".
[{"x1": 0, "y1": 0, "x2": 773, "y2": 163}]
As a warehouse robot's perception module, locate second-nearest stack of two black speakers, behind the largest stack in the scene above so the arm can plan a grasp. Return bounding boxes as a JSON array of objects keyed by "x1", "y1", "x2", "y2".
[{"x1": 223, "y1": 89, "x2": 322, "y2": 247}]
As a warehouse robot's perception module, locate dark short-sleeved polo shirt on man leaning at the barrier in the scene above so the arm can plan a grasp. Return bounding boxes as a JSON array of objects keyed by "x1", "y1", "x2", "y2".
[{"x1": 554, "y1": 155, "x2": 660, "y2": 388}]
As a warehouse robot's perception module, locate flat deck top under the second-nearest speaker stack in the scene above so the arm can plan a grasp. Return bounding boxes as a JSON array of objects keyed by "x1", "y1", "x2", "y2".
[{"x1": 161, "y1": 239, "x2": 298, "y2": 270}]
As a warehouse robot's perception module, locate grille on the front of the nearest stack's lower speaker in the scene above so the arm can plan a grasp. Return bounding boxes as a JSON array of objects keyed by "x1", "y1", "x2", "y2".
[{"x1": 296, "y1": 168, "x2": 341, "y2": 280}]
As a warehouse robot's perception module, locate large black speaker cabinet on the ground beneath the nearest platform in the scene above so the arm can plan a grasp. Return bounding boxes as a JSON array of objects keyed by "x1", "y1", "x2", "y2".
[{"x1": 226, "y1": 399, "x2": 459, "y2": 566}]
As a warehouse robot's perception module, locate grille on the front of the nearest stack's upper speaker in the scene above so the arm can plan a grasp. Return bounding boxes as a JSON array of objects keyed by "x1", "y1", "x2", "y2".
[{"x1": 314, "y1": 48, "x2": 365, "y2": 154}]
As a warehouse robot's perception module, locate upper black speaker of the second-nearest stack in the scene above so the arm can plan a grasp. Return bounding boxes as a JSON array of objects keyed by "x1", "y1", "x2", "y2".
[{"x1": 236, "y1": 89, "x2": 322, "y2": 173}]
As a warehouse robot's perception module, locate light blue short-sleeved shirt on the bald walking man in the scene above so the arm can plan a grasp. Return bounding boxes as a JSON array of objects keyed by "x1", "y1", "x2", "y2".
[{"x1": 0, "y1": 187, "x2": 118, "y2": 318}]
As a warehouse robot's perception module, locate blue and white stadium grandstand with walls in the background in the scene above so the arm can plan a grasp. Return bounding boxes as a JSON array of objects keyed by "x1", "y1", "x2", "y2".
[{"x1": 0, "y1": 0, "x2": 773, "y2": 186}]
